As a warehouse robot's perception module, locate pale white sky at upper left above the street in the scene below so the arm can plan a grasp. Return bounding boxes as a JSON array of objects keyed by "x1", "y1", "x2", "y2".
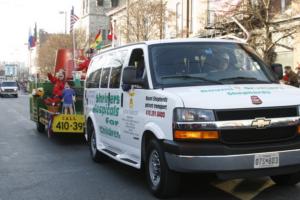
[{"x1": 0, "y1": 0, "x2": 81, "y2": 62}]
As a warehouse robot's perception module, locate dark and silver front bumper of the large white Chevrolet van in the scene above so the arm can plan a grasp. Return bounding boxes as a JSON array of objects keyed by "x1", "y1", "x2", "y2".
[{"x1": 163, "y1": 139, "x2": 300, "y2": 175}]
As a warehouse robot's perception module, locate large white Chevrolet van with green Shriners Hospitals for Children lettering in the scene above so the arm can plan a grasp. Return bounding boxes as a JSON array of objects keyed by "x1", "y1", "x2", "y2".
[{"x1": 84, "y1": 39, "x2": 300, "y2": 197}]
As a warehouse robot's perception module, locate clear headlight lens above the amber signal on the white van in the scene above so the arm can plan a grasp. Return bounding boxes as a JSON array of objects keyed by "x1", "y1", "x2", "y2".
[{"x1": 174, "y1": 108, "x2": 215, "y2": 122}]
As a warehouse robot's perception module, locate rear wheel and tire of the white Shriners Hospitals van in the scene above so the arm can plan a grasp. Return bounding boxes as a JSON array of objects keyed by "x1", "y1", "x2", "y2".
[{"x1": 88, "y1": 125, "x2": 107, "y2": 163}]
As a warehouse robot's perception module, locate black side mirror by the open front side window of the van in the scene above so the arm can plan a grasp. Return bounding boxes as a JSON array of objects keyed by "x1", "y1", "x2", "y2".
[{"x1": 122, "y1": 66, "x2": 145, "y2": 91}]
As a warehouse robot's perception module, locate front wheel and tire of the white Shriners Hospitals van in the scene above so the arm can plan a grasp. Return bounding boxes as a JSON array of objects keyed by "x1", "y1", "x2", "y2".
[{"x1": 145, "y1": 139, "x2": 180, "y2": 198}]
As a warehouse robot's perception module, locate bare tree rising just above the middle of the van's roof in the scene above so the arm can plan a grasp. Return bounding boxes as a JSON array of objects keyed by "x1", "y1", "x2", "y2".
[{"x1": 120, "y1": 0, "x2": 166, "y2": 42}]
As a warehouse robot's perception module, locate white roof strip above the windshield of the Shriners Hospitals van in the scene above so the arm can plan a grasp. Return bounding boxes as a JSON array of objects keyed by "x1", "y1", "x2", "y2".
[{"x1": 96, "y1": 38, "x2": 245, "y2": 55}]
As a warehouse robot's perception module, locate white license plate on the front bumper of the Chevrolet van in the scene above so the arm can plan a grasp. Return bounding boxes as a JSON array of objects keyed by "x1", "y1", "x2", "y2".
[{"x1": 254, "y1": 153, "x2": 279, "y2": 168}]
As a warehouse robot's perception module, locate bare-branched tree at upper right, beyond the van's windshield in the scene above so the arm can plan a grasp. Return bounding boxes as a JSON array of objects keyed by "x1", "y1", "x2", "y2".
[{"x1": 216, "y1": 0, "x2": 300, "y2": 64}]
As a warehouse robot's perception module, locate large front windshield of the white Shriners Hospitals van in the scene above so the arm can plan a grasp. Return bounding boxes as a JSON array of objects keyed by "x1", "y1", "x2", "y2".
[{"x1": 149, "y1": 42, "x2": 275, "y2": 88}]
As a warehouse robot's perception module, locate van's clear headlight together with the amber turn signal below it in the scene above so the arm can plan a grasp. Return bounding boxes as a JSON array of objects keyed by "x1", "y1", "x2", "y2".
[{"x1": 173, "y1": 108, "x2": 219, "y2": 141}]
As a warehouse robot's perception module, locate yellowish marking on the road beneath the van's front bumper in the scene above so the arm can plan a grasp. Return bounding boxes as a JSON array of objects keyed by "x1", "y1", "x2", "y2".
[{"x1": 211, "y1": 178, "x2": 275, "y2": 200}]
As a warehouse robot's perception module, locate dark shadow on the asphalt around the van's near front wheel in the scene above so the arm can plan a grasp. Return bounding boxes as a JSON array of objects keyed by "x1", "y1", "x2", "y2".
[{"x1": 92, "y1": 155, "x2": 237, "y2": 200}]
